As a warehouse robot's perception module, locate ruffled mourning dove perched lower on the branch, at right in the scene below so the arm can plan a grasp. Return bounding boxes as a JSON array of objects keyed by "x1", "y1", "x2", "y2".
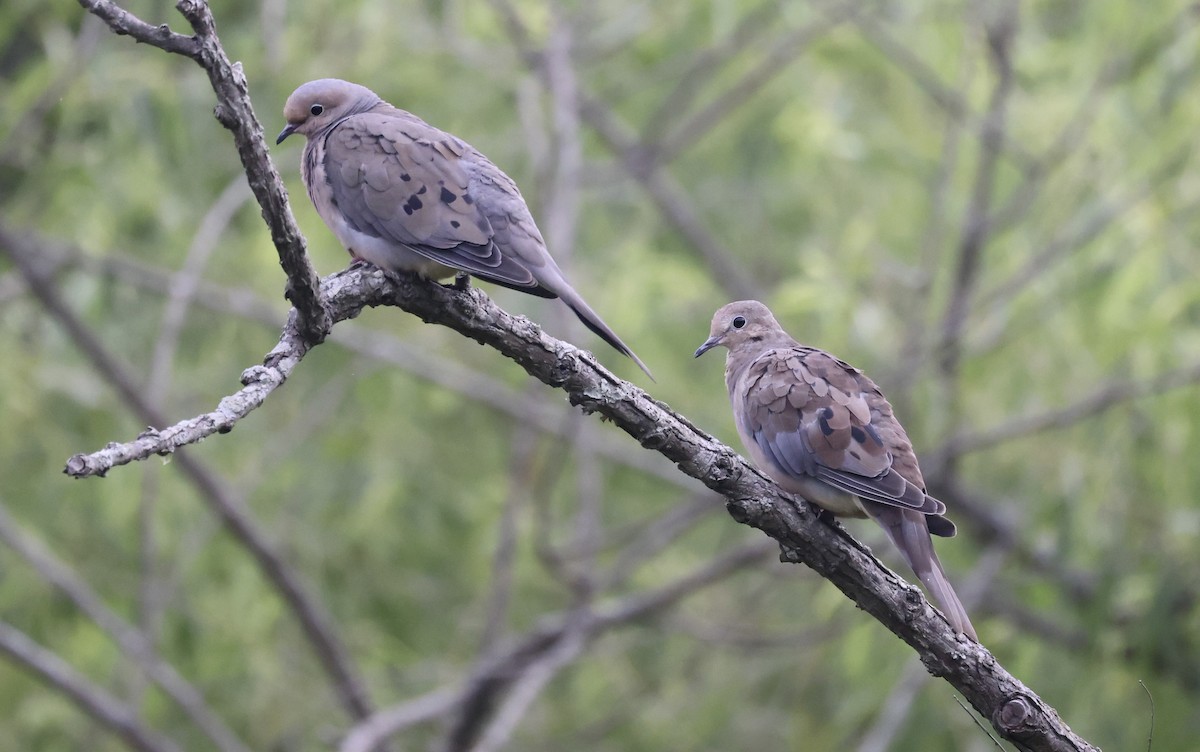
[{"x1": 696, "y1": 300, "x2": 978, "y2": 640}]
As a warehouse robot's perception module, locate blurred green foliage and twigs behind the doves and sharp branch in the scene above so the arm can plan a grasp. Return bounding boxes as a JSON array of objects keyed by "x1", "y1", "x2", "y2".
[{"x1": 0, "y1": 0, "x2": 1200, "y2": 752}]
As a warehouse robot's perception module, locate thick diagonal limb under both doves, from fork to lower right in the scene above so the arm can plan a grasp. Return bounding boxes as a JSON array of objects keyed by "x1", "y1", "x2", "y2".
[{"x1": 60, "y1": 257, "x2": 1092, "y2": 750}]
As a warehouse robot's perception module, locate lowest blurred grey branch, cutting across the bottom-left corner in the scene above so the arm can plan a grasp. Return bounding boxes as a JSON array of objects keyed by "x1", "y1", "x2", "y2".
[{"x1": 0, "y1": 621, "x2": 182, "y2": 752}]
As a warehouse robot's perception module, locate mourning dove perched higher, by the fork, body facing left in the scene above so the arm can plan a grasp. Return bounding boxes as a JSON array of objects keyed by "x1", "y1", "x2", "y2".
[{"x1": 275, "y1": 78, "x2": 654, "y2": 379}]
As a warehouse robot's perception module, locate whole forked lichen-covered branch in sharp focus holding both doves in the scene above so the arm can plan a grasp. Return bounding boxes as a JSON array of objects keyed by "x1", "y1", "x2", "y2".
[{"x1": 60, "y1": 0, "x2": 1094, "y2": 751}]
